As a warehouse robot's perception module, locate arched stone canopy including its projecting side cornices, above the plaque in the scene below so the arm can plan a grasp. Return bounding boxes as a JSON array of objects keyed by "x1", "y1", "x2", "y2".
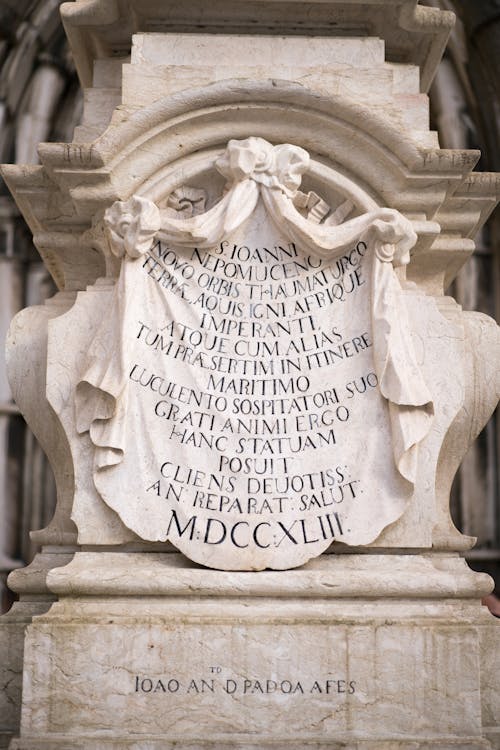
[{"x1": 4, "y1": 80, "x2": 495, "y2": 296}]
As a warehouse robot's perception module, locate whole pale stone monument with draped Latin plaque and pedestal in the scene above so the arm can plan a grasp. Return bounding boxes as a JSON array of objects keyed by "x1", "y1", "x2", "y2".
[{"x1": 0, "y1": 0, "x2": 500, "y2": 750}]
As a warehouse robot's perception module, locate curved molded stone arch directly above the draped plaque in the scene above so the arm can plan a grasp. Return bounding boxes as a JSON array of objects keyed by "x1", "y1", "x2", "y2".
[{"x1": 40, "y1": 80, "x2": 458, "y2": 215}]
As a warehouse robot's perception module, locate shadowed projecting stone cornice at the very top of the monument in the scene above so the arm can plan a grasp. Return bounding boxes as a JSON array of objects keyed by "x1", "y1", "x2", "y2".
[{"x1": 61, "y1": 0, "x2": 455, "y2": 91}]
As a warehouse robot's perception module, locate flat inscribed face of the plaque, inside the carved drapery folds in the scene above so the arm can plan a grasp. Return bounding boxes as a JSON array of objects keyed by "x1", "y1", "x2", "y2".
[{"x1": 96, "y1": 207, "x2": 406, "y2": 569}]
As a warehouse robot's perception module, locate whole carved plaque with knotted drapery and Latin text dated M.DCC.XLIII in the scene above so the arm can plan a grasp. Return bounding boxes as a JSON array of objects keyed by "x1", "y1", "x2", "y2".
[{"x1": 77, "y1": 139, "x2": 431, "y2": 570}]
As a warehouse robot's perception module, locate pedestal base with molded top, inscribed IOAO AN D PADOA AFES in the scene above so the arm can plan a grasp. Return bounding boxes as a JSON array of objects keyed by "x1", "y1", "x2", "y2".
[{"x1": 4, "y1": 553, "x2": 500, "y2": 750}]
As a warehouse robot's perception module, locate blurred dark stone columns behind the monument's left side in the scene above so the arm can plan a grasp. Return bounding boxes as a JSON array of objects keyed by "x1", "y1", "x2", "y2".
[{"x1": 0, "y1": 0, "x2": 83, "y2": 611}]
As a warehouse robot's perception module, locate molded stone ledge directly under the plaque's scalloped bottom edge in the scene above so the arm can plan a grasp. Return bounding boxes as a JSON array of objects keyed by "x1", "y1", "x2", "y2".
[{"x1": 46, "y1": 552, "x2": 492, "y2": 599}]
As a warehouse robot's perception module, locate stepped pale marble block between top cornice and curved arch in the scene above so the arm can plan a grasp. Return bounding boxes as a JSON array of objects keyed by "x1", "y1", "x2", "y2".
[{"x1": 118, "y1": 33, "x2": 438, "y2": 147}]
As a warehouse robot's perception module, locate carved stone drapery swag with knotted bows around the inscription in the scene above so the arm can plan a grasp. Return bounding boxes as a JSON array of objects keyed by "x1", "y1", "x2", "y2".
[{"x1": 79, "y1": 138, "x2": 433, "y2": 483}]
